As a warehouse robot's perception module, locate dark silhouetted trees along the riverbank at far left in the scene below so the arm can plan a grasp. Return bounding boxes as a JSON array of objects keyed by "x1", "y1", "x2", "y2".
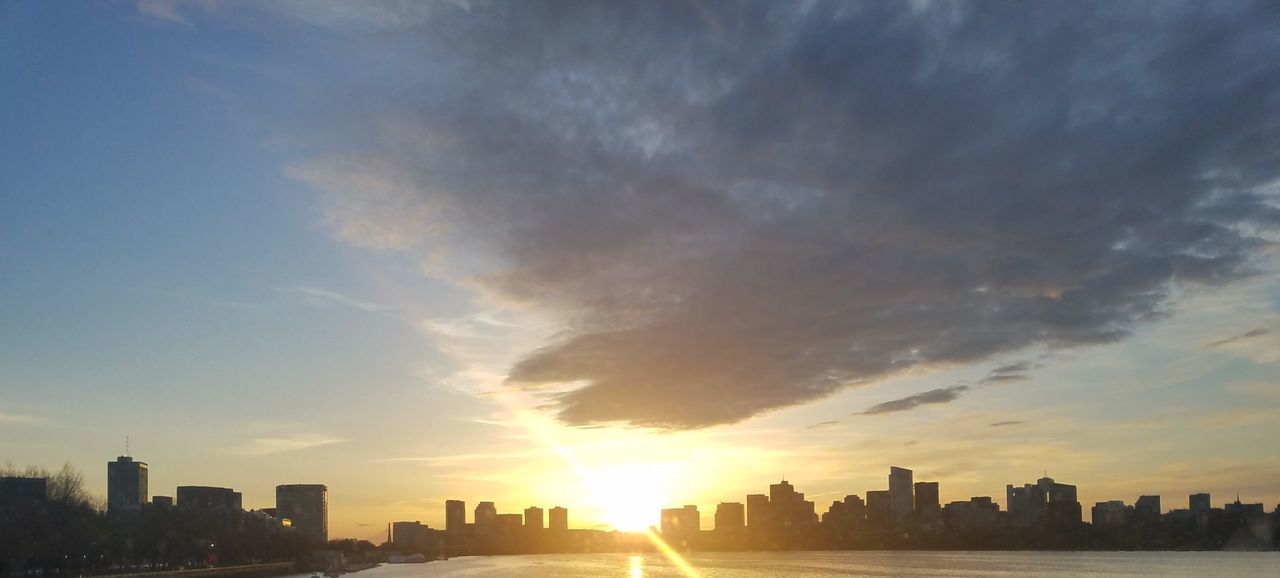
[{"x1": 0, "y1": 465, "x2": 310, "y2": 578}]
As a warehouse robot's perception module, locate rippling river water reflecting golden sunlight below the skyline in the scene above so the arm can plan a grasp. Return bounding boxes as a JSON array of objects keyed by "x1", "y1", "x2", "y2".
[{"x1": 340, "y1": 551, "x2": 1280, "y2": 578}]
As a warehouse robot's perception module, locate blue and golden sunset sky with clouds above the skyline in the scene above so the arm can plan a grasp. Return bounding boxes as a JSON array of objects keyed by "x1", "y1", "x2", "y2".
[{"x1": 0, "y1": 0, "x2": 1280, "y2": 540}]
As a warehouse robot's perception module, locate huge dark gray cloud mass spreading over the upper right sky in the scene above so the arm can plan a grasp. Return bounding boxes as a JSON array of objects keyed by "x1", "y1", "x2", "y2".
[{"x1": 293, "y1": 1, "x2": 1280, "y2": 428}]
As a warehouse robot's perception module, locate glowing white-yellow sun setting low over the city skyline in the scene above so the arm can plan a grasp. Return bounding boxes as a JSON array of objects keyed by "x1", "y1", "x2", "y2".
[{"x1": 590, "y1": 464, "x2": 671, "y2": 532}]
